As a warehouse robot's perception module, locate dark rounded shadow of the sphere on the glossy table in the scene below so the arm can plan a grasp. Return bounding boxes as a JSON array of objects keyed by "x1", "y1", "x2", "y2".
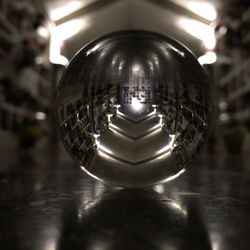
[{"x1": 58, "y1": 190, "x2": 212, "y2": 250}]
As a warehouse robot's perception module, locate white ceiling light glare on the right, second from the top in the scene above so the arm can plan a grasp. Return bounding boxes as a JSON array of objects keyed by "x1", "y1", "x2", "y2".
[{"x1": 179, "y1": 18, "x2": 216, "y2": 50}]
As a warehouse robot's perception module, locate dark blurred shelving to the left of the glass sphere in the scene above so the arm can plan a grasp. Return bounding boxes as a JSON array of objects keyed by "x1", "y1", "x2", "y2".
[{"x1": 0, "y1": 0, "x2": 51, "y2": 138}]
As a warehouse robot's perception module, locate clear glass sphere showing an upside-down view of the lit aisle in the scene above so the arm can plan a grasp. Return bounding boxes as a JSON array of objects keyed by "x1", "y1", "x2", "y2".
[{"x1": 56, "y1": 31, "x2": 213, "y2": 187}]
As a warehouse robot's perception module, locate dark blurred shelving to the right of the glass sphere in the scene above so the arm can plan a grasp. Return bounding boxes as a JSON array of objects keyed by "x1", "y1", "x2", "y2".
[{"x1": 215, "y1": 1, "x2": 250, "y2": 123}]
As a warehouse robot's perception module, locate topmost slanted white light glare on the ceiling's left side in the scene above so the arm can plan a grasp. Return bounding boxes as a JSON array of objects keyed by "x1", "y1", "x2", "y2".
[{"x1": 49, "y1": 1, "x2": 83, "y2": 21}]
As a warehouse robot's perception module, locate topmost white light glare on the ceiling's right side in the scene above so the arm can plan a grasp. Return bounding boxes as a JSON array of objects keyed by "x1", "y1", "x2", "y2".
[{"x1": 187, "y1": 1, "x2": 217, "y2": 21}]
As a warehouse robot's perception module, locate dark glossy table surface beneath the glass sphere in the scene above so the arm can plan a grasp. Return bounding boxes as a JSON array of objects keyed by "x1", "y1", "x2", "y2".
[{"x1": 0, "y1": 142, "x2": 250, "y2": 250}]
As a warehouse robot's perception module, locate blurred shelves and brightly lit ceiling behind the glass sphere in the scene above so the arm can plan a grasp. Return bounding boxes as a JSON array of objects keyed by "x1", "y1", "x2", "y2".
[{"x1": 0, "y1": 0, "x2": 250, "y2": 158}]
